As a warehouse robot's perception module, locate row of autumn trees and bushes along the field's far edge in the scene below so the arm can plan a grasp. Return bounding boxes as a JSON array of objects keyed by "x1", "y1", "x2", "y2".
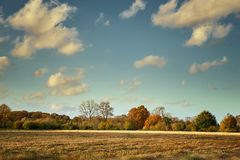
[{"x1": 0, "y1": 100, "x2": 240, "y2": 132}]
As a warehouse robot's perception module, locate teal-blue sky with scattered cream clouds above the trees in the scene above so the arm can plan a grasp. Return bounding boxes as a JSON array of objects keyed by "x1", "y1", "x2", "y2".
[{"x1": 0, "y1": 0, "x2": 240, "y2": 120}]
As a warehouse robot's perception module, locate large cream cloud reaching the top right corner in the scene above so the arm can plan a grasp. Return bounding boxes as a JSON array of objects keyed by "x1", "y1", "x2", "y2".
[{"x1": 152, "y1": 0, "x2": 240, "y2": 46}]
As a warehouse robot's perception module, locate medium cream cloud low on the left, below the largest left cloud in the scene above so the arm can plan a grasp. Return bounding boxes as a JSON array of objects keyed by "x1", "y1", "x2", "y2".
[{"x1": 47, "y1": 70, "x2": 87, "y2": 96}]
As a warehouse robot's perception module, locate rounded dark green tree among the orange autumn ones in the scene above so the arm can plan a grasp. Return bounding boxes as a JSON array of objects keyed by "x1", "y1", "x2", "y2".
[{"x1": 195, "y1": 111, "x2": 217, "y2": 131}]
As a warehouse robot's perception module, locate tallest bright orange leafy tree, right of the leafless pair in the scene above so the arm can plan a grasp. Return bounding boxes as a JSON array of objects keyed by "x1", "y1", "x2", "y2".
[{"x1": 128, "y1": 105, "x2": 149, "y2": 129}]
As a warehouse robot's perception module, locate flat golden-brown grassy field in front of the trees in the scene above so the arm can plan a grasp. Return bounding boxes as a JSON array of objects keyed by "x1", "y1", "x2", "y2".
[{"x1": 0, "y1": 131, "x2": 240, "y2": 160}]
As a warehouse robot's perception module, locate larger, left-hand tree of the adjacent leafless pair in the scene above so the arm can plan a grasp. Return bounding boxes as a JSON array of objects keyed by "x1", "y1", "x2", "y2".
[{"x1": 79, "y1": 100, "x2": 98, "y2": 119}]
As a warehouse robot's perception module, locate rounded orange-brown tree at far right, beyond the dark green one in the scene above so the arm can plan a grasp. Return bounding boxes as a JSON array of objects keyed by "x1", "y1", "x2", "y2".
[{"x1": 220, "y1": 114, "x2": 237, "y2": 132}]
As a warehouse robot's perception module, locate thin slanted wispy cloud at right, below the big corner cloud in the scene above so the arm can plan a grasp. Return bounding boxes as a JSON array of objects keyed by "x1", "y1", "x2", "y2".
[{"x1": 188, "y1": 56, "x2": 228, "y2": 74}]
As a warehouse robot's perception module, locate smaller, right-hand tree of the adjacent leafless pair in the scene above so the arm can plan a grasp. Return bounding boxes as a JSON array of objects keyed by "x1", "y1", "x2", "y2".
[{"x1": 98, "y1": 102, "x2": 113, "y2": 120}]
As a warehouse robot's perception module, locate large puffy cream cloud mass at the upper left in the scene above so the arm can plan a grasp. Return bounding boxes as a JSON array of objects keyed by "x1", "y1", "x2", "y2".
[{"x1": 8, "y1": 0, "x2": 84, "y2": 58}]
